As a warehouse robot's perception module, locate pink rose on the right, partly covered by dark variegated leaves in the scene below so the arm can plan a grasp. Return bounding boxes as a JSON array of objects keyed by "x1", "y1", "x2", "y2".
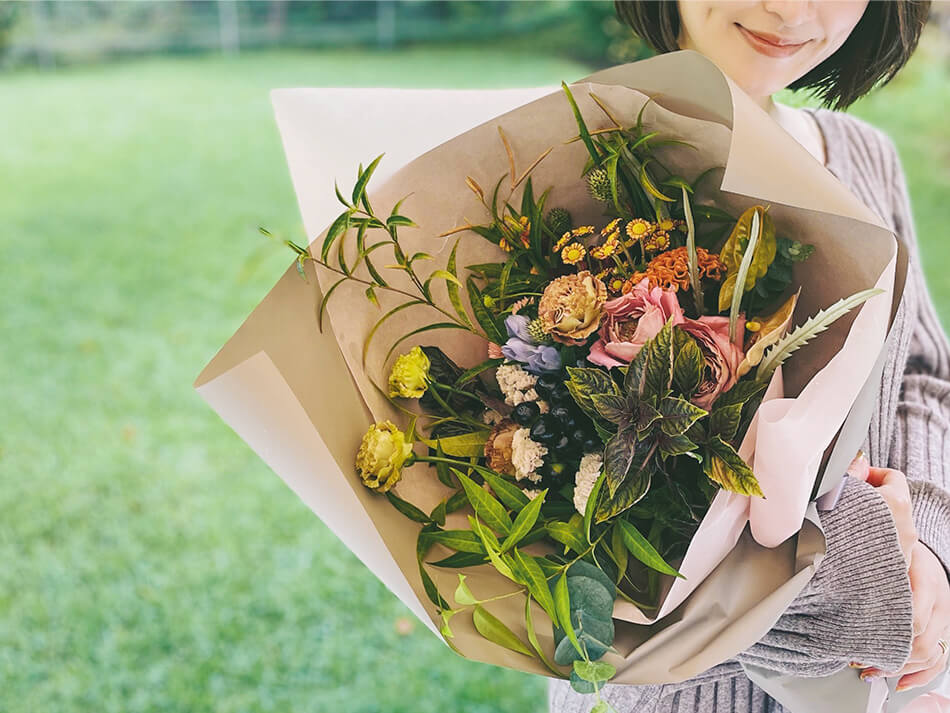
[{"x1": 681, "y1": 314, "x2": 745, "y2": 410}]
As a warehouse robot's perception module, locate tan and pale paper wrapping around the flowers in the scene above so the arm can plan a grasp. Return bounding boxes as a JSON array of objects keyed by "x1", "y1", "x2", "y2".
[{"x1": 195, "y1": 51, "x2": 906, "y2": 700}]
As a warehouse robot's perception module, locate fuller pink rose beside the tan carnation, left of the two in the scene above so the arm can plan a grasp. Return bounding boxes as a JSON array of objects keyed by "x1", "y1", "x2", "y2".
[{"x1": 587, "y1": 277, "x2": 685, "y2": 368}]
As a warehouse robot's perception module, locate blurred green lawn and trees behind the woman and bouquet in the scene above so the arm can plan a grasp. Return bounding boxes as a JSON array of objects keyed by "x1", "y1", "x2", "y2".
[{"x1": 0, "y1": 0, "x2": 950, "y2": 713}]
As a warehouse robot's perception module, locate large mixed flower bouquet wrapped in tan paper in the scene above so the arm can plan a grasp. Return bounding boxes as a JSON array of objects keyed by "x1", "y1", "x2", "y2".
[{"x1": 198, "y1": 52, "x2": 903, "y2": 710}]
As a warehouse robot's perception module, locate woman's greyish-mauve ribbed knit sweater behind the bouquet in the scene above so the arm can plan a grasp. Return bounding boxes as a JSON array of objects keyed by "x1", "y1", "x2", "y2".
[{"x1": 549, "y1": 109, "x2": 950, "y2": 713}]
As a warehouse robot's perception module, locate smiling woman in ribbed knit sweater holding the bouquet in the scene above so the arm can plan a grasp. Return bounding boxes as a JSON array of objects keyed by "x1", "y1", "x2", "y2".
[{"x1": 549, "y1": 0, "x2": 950, "y2": 713}]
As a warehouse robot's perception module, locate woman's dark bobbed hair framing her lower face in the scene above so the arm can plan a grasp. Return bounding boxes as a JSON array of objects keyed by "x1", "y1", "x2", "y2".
[{"x1": 614, "y1": 0, "x2": 930, "y2": 109}]
